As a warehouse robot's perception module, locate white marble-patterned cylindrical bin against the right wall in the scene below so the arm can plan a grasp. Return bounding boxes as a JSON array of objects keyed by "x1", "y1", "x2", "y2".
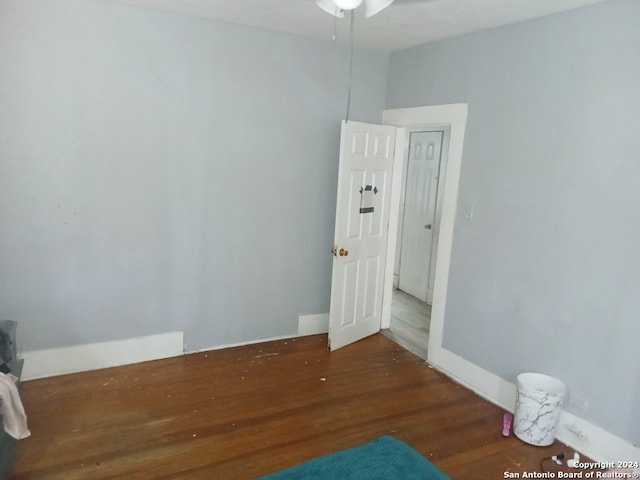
[{"x1": 513, "y1": 373, "x2": 567, "y2": 447}]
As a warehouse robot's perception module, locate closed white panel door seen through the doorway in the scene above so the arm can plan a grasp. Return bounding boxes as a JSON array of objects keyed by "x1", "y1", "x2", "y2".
[{"x1": 398, "y1": 131, "x2": 443, "y2": 302}]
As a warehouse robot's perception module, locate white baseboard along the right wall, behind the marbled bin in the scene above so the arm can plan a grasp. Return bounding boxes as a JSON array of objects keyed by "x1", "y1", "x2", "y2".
[{"x1": 429, "y1": 345, "x2": 640, "y2": 462}]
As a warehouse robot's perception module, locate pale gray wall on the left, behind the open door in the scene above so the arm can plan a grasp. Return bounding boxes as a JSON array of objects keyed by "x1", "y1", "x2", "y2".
[{"x1": 0, "y1": 0, "x2": 388, "y2": 350}]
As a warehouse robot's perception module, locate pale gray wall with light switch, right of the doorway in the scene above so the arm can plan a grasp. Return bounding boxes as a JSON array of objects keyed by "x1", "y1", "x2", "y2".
[{"x1": 387, "y1": 0, "x2": 640, "y2": 442}]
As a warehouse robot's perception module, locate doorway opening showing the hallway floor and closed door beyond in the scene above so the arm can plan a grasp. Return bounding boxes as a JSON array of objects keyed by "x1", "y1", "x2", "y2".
[{"x1": 382, "y1": 126, "x2": 450, "y2": 360}]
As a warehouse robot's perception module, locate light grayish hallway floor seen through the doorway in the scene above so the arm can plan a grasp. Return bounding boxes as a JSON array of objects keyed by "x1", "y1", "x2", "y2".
[{"x1": 382, "y1": 289, "x2": 431, "y2": 360}]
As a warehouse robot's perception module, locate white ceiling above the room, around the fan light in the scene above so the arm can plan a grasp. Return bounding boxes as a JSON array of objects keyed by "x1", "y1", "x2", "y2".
[{"x1": 103, "y1": 0, "x2": 605, "y2": 52}]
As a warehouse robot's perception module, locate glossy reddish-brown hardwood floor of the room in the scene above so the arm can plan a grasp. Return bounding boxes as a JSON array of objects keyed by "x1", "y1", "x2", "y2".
[{"x1": 11, "y1": 335, "x2": 584, "y2": 480}]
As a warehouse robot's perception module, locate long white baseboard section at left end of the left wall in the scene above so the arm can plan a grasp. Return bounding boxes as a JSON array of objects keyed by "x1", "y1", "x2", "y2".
[{"x1": 19, "y1": 332, "x2": 184, "y2": 381}]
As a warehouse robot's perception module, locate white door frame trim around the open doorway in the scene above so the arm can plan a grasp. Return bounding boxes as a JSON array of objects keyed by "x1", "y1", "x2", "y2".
[{"x1": 381, "y1": 103, "x2": 468, "y2": 367}]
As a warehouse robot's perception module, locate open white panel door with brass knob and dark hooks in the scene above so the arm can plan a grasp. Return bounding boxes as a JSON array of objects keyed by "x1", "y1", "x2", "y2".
[{"x1": 329, "y1": 121, "x2": 396, "y2": 350}]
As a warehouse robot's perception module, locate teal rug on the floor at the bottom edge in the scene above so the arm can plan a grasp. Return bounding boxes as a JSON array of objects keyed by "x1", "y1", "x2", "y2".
[{"x1": 256, "y1": 435, "x2": 449, "y2": 480}]
